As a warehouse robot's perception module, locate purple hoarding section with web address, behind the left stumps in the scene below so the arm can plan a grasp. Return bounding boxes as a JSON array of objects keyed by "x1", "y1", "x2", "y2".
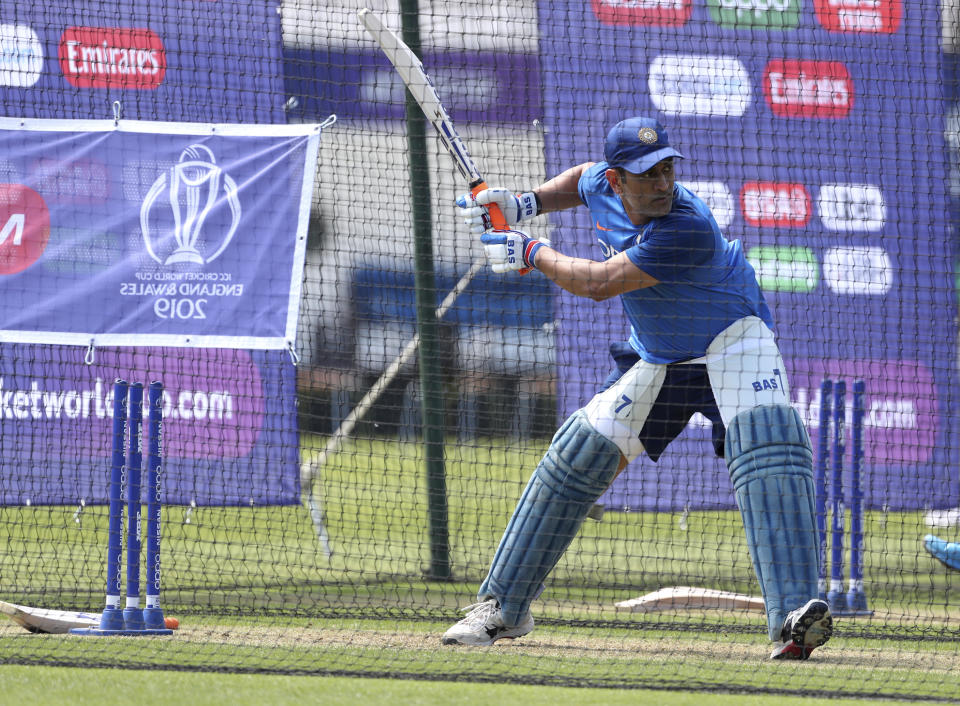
[{"x1": 0, "y1": 344, "x2": 300, "y2": 505}]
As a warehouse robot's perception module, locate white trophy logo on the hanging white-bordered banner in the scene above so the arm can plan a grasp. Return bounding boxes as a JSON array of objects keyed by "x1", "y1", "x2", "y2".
[{"x1": 140, "y1": 145, "x2": 240, "y2": 265}]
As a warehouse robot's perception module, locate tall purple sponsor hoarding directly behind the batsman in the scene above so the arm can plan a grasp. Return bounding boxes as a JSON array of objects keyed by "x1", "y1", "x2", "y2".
[{"x1": 539, "y1": 0, "x2": 960, "y2": 510}]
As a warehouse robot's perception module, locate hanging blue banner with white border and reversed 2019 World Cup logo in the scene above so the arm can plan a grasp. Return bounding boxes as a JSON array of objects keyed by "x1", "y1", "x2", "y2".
[{"x1": 0, "y1": 119, "x2": 320, "y2": 349}]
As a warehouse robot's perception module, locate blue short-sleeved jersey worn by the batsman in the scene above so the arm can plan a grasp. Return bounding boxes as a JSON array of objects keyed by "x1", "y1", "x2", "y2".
[{"x1": 578, "y1": 162, "x2": 773, "y2": 364}]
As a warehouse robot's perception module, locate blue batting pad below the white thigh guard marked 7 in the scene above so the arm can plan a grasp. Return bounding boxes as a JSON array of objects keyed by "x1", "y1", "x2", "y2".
[{"x1": 478, "y1": 411, "x2": 620, "y2": 625}]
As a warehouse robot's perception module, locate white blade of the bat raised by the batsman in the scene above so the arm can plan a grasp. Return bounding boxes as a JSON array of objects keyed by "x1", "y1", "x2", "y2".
[{"x1": 357, "y1": 8, "x2": 483, "y2": 185}]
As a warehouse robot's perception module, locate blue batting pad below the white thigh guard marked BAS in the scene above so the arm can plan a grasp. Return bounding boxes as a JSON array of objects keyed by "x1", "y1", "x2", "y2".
[{"x1": 726, "y1": 405, "x2": 818, "y2": 641}]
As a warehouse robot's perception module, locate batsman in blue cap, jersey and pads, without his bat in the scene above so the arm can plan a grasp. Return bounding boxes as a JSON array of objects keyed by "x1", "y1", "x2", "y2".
[{"x1": 442, "y1": 117, "x2": 833, "y2": 660}]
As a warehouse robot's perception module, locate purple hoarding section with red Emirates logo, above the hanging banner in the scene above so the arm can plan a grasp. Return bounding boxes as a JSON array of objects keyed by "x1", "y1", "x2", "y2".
[{"x1": 0, "y1": 0, "x2": 286, "y2": 123}]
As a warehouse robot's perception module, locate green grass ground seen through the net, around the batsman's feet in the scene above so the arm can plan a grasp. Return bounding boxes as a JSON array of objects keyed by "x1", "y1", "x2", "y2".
[{"x1": 0, "y1": 439, "x2": 960, "y2": 703}]
